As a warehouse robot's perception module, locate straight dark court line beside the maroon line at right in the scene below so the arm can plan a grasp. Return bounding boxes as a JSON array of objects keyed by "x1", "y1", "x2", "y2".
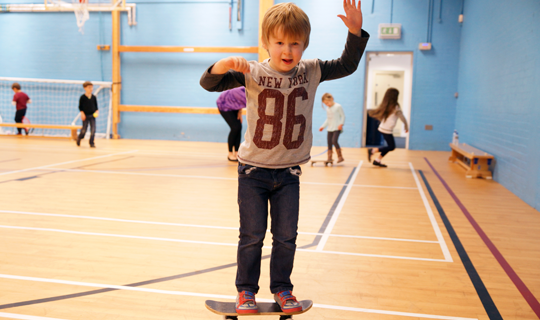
[{"x1": 418, "y1": 170, "x2": 502, "y2": 320}]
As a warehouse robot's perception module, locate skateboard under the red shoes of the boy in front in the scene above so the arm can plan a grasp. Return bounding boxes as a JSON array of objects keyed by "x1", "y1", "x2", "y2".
[{"x1": 205, "y1": 300, "x2": 313, "y2": 320}]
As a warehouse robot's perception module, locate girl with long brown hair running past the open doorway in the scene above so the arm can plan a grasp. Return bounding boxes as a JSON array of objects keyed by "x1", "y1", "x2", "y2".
[{"x1": 368, "y1": 88, "x2": 409, "y2": 168}]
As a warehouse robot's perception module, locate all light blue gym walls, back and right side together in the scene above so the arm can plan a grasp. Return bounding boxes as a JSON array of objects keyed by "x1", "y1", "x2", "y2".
[{"x1": 0, "y1": 0, "x2": 540, "y2": 209}]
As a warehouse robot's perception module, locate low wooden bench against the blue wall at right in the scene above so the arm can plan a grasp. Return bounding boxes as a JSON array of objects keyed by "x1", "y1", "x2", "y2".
[{"x1": 448, "y1": 143, "x2": 493, "y2": 179}]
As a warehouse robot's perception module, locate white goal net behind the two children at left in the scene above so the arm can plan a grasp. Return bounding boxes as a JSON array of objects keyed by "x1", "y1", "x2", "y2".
[{"x1": 0, "y1": 77, "x2": 112, "y2": 139}]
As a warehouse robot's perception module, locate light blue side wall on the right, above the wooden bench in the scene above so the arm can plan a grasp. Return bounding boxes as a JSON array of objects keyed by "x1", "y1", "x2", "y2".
[{"x1": 456, "y1": 0, "x2": 540, "y2": 209}]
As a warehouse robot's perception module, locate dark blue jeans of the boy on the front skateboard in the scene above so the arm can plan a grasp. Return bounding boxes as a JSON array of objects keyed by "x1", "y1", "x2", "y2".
[{"x1": 236, "y1": 163, "x2": 302, "y2": 293}]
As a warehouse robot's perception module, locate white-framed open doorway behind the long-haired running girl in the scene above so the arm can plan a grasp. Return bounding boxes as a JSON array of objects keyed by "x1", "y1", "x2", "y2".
[{"x1": 361, "y1": 52, "x2": 413, "y2": 149}]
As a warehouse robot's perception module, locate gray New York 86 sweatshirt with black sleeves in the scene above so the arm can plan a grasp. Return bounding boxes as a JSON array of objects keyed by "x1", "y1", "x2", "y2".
[{"x1": 200, "y1": 30, "x2": 369, "y2": 169}]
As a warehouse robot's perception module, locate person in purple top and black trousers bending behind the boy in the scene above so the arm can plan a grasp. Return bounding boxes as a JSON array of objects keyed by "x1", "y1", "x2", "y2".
[{"x1": 216, "y1": 87, "x2": 246, "y2": 161}]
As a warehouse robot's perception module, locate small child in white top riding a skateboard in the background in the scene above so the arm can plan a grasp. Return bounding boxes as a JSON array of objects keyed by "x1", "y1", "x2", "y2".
[{"x1": 319, "y1": 93, "x2": 345, "y2": 163}]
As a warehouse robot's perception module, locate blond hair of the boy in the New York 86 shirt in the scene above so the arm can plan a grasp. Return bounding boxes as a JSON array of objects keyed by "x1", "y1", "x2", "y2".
[{"x1": 261, "y1": 2, "x2": 311, "y2": 50}]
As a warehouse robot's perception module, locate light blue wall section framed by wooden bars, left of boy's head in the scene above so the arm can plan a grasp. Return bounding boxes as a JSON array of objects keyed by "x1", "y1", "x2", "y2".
[{"x1": 119, "y1": 1, "x2": 259, "y2": 142}]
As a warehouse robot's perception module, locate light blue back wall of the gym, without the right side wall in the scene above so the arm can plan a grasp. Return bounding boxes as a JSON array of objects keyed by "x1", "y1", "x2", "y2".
[{"x1": 0, "y1": 0, "x2": 461, "y2": 150}]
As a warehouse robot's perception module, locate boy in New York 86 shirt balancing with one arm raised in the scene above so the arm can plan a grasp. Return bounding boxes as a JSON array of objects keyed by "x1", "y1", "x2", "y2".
[{"x1": 201, "y1": 0, "x2": 369, "y2": 314}]
